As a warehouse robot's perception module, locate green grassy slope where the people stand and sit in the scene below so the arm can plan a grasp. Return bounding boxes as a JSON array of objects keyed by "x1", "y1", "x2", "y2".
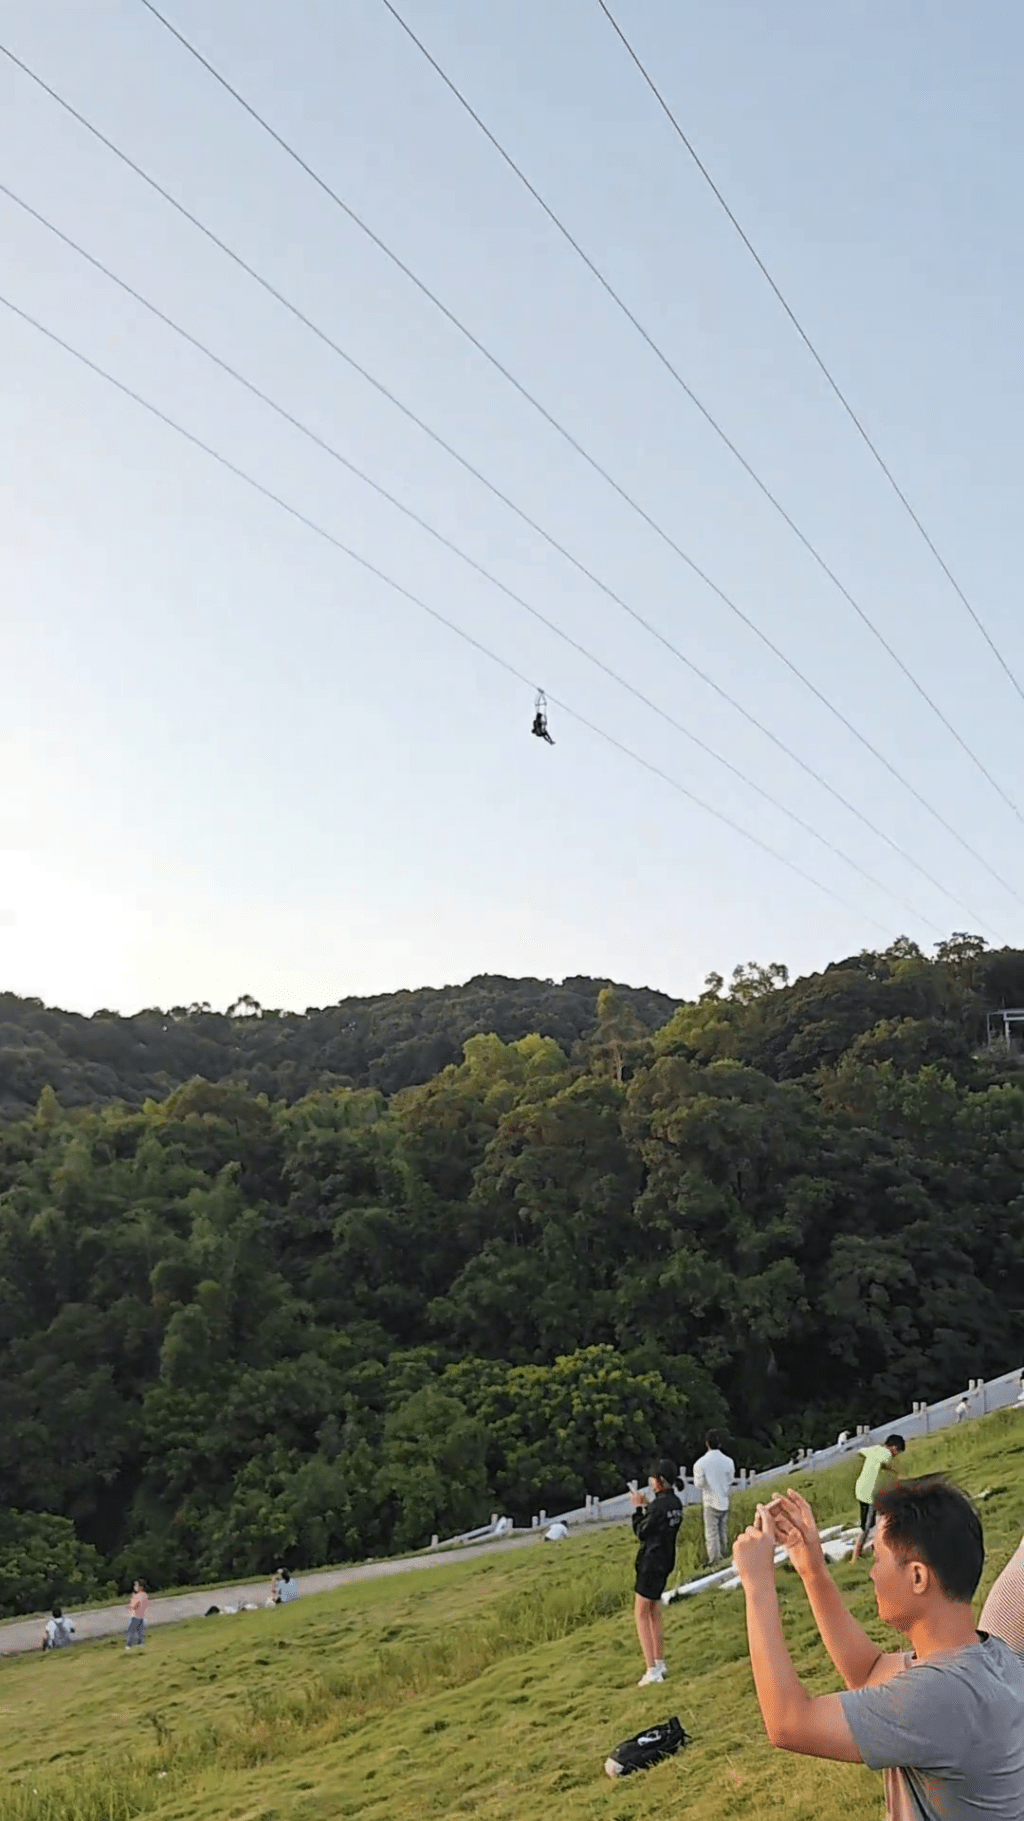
[{"x1": 0, "y1": 1411, "x2": 1024, "y2": 1821}]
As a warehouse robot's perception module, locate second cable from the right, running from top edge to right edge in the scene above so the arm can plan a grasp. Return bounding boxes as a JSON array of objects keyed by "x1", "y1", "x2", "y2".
[{"x1": 373, "y1": 0, "x2": 1024, "y2": 823}]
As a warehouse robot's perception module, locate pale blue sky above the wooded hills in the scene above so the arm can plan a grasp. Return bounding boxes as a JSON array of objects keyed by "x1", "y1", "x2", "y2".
[{"x1": 0, "y1": 0, "x2": 1024, "y2": 1011}]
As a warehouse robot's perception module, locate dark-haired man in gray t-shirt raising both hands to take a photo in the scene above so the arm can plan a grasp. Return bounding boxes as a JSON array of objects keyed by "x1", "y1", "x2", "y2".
[{"x1": 732, "y1": 1475, "x2": 1024, "y2": 1821}]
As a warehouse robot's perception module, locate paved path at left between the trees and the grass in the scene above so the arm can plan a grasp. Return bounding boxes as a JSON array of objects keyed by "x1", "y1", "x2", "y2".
[{"x1": 0, "y1": 1530, "x2": 543, "y2": 1657}]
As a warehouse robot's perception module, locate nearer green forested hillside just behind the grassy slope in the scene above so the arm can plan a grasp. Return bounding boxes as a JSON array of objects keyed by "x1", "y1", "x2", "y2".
[{"x1": 0, "y1": 938, "x2": 1024, "y2": 1610}]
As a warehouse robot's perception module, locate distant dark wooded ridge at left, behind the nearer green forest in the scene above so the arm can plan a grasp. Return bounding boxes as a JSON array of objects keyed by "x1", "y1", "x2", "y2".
[{"x1": 0, "y1": 974, "x2": 678, "y2": 1118}]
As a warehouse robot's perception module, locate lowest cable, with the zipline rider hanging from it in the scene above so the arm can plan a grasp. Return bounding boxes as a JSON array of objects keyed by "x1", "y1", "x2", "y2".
[{"x1": 0, "y1": 293, "x2": 889, "y2": 934}]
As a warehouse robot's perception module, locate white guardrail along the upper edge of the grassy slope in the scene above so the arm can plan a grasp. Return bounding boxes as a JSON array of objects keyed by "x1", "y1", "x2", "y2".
[{"x1": 430, "y1": 1368, "x2": 1024, "y2": 1550}]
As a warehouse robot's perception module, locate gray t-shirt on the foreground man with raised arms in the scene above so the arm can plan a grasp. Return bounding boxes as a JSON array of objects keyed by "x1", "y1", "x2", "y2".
[{"x1": 840, "y1": 1637, "x2": 1024, "y2": 1821}]
